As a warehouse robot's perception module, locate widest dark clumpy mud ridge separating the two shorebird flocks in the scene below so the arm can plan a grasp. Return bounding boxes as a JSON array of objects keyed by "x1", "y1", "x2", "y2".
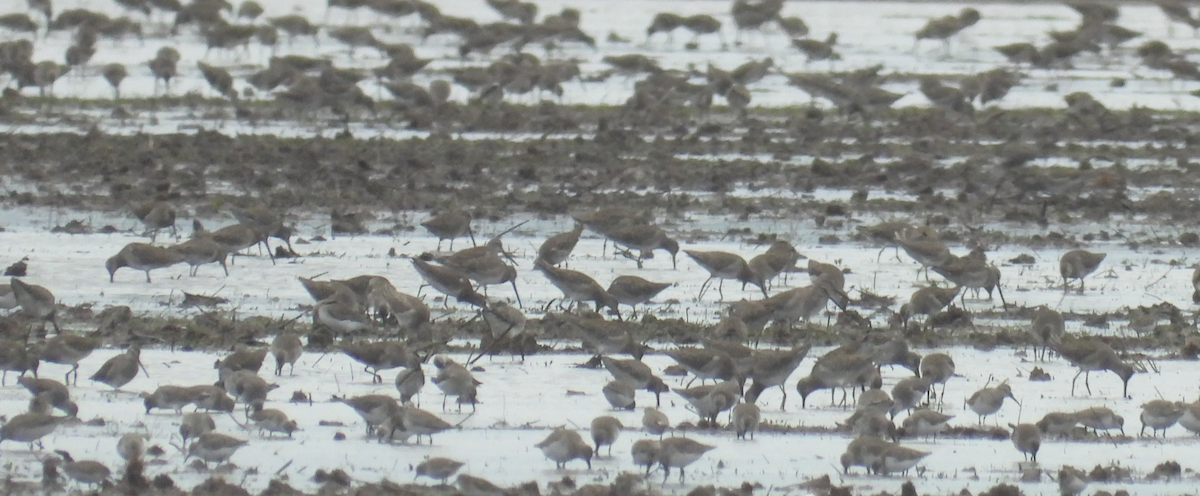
[{"x1": 7, "y1": 101, "x2": 1200, "y2": 235}]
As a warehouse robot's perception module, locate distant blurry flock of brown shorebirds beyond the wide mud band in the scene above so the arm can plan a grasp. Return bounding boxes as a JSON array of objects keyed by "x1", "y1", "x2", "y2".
[{"x1": 0, "y1": 0, "x2": 1200, "y2": 114}]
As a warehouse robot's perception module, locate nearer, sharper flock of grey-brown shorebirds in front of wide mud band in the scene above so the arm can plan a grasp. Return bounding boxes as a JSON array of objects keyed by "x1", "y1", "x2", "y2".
[{"x1": 0, "y1": 195, "x2": 1200, "y2": 494}]
